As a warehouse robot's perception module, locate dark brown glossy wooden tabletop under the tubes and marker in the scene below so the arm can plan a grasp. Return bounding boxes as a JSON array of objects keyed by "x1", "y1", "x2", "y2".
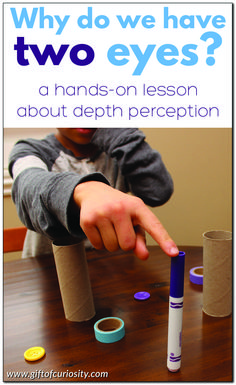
[{"x1": 4, "y1": 247, "x2": 232, "y2": 382}]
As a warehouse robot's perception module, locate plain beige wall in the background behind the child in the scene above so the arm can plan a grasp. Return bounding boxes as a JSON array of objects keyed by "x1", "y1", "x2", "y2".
[{"x1": 4, "y1": 128, "x2": 232, "y2": 258}]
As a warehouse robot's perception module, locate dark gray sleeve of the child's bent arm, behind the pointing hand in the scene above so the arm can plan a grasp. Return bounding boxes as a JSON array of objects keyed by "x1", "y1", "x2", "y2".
[{"x1": 92, "y1": 128, "x2": 173, "y2": 207}]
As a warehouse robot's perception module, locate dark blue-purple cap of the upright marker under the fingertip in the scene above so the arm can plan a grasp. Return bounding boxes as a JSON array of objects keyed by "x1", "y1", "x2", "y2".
[{"x1": 170, "y1": 251, "x2": 185, "y2": 298}]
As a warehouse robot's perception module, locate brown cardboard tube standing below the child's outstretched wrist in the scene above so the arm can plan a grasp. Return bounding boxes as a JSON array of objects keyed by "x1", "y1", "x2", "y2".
[{"x1": 53, "y1": 242, "x2": 95, "y2": 322}]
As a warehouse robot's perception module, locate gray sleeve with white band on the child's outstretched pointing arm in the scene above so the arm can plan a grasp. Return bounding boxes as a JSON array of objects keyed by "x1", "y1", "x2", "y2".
[{"x1": 9, "y1": 143, "x2": 109, "y2": 240}]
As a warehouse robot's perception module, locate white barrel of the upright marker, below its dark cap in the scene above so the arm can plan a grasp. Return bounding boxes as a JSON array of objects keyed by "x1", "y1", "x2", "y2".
[{"x1": 167, "y1": 297, "x2": 183, "y2": 372}]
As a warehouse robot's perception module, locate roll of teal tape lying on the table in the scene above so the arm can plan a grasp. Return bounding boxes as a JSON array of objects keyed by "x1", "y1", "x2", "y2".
[{"x1": 94, "y1": 317, "x2": 125, "y2": 344}]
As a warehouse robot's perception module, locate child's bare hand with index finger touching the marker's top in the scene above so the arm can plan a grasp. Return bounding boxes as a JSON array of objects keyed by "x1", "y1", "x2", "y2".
[{"x1": 73, "y1": 181, "x2": 179, "y2": 259}]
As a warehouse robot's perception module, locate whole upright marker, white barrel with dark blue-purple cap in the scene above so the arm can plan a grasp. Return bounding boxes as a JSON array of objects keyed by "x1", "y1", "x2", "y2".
[{"x1": 167, "y1": 251, "x2": 185, "y2": 372}]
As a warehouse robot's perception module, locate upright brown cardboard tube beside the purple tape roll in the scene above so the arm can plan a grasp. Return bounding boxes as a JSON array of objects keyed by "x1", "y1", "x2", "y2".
[{"x1": 203, "y1": 230, "x2": 232, "y2": 317}]
